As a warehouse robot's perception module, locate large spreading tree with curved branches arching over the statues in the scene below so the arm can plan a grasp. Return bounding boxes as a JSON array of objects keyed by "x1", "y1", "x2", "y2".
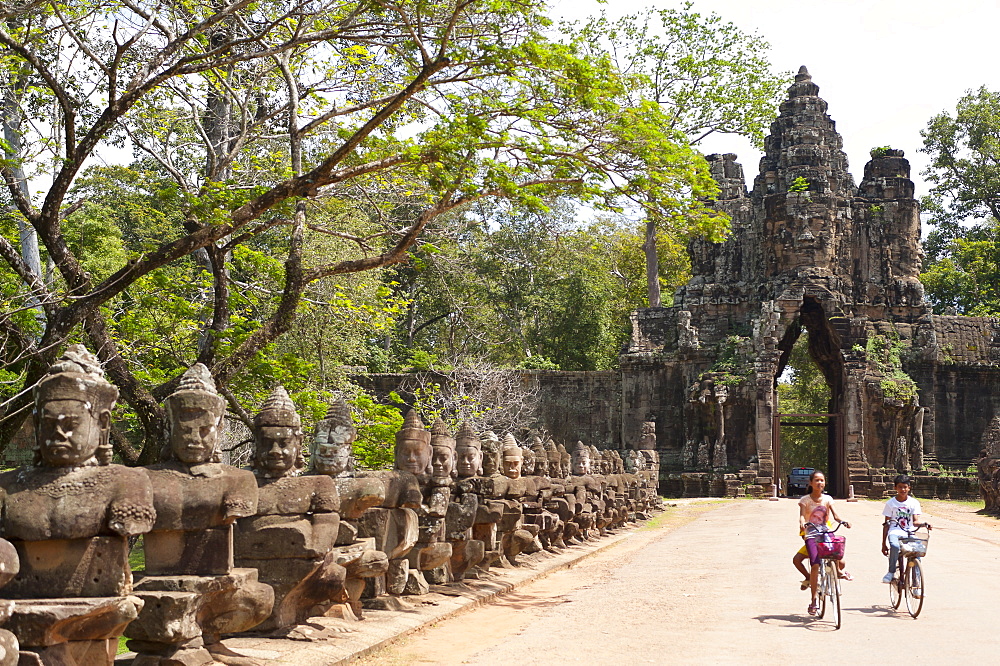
[{"x1": 0, "y1": 0, "x2": 725, "y2": 462}]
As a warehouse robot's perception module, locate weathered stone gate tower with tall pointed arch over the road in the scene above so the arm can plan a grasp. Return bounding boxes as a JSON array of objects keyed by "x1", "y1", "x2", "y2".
[{"x1": 621, "y1": 67, "x2": 1000, "y2": 496}]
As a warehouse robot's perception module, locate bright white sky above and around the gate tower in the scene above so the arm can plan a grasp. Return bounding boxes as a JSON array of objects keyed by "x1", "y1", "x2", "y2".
[{"x1": 550, "y1": 0, "x2": 1000, "y2": 197}]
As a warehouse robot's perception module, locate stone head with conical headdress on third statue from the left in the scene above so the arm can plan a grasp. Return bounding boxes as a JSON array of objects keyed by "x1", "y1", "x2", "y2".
[{"x1": 253, "y1": 386, "x2": 305, "y2": 478}]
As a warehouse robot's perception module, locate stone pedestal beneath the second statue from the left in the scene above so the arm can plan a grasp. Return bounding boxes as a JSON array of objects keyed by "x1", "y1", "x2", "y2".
[{"x1": 125, "y1": 569, "x2": 274, "y2": 666}]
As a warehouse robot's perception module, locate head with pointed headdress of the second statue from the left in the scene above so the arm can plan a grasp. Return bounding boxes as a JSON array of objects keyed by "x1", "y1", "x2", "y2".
[{"x1": 163, "y1": 363, "x2": 226, "y2": 465}]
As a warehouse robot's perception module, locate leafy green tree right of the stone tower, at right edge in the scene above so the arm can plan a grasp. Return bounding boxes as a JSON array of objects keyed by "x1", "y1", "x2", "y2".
[{"x1": 921, "y1": 87, "x2": 1000, "y2": 315}]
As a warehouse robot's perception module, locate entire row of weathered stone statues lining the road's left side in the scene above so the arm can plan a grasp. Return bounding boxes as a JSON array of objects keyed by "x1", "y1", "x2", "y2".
[{"x1": 0, "y1": 345, "x2": 659, "y2": 666}]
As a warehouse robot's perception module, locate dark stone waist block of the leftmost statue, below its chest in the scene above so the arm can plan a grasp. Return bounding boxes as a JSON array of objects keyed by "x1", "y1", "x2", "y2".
[{"x1": 3, "y1": 536, "x2": 132, "y2": 599}]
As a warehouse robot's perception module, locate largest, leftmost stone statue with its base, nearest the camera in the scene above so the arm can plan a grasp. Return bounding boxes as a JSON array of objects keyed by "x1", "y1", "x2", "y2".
[{"x1": 0, "y1": 345, "x2": 156, "y2": 666}]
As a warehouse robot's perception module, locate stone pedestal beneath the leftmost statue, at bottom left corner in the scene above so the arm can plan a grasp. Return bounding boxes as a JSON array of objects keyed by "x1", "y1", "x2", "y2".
[{"x1": 7, "y1": 596, "x2": 143, "y2": 666}]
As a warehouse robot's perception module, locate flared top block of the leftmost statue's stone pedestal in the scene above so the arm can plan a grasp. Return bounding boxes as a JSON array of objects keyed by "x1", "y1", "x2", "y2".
[{"x1": 6, "y1": 596, "x2": 143, "y2": 648}]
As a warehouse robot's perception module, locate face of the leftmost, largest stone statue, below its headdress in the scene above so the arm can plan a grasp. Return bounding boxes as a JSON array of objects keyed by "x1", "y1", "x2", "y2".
[{"x1": 35, "y1": 400, "x2": 105, "y2": 467}]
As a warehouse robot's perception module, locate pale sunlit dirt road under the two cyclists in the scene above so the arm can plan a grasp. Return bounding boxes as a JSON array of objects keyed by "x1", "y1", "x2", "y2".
[{"x1": 361, "y1": 500, "x2": 1000, "y2": 665}]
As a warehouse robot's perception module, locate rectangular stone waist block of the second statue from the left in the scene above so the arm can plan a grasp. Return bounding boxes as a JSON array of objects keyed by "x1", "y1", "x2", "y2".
[{"x1": 142, "y1": 525, "x2": 233, "y2": 576}]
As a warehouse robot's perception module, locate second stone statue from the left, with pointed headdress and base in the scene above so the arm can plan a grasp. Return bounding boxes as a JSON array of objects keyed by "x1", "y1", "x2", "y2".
[{"x1": 126, "y1": 363, "x2": 274, "y2": 666}]
